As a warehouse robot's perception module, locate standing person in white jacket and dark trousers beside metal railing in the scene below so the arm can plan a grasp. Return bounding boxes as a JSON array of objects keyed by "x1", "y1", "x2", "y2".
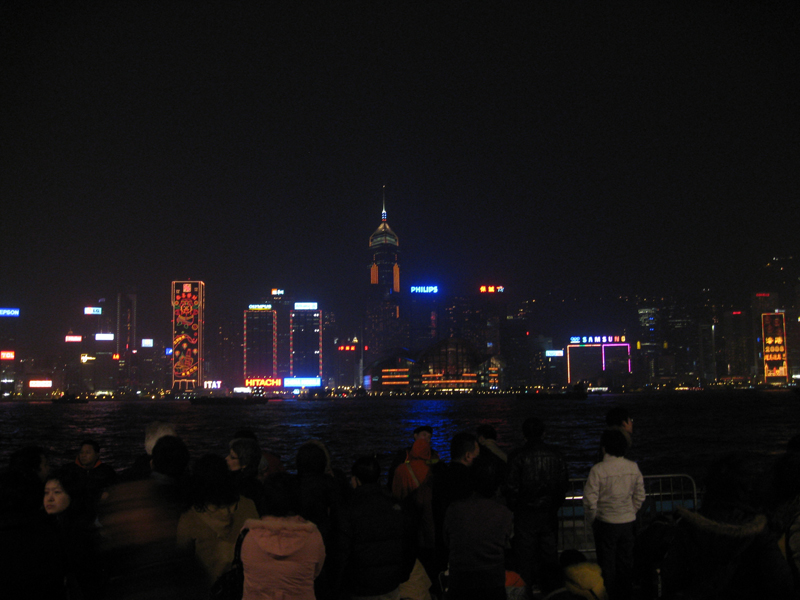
[{"x1": 583, "y1": 429, "x2": 645, "y2": 600}]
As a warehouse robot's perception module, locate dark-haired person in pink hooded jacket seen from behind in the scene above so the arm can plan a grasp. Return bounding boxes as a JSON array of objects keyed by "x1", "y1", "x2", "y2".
[{"x1": 241, "y1": 473, "x2": 325, "y2": 600}]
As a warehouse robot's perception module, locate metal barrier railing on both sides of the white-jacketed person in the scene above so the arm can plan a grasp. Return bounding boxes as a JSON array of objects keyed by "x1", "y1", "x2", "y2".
[{"x1": 558, "y1": 474, "x2": 697, "y2": 554}]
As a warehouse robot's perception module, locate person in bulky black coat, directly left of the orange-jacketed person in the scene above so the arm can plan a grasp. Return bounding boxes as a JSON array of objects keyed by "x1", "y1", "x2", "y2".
[{"x1": 337, "y1": 456, "x2": 415, "y2": 599}]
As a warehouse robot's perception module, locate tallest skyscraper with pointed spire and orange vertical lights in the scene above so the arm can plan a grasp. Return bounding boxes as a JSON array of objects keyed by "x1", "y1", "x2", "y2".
[{"x1": 364, "y1": 191, "x2": 407, "y2": 362}]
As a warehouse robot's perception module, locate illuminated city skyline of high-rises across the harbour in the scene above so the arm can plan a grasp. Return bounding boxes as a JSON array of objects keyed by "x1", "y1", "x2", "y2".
[{"x1": 0, "y1": 202, "x2": 800, "y2": 401}]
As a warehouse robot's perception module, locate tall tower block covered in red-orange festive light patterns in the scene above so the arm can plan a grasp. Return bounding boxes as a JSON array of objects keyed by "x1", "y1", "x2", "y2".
[{"x1": 172, "y1": 281, "x2": 205, "y2": 390}]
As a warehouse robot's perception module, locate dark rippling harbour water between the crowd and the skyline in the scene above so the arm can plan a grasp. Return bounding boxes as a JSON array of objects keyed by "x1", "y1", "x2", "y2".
[{"x1": 0, "y1": 391, "x2": 800, "y2": 484}]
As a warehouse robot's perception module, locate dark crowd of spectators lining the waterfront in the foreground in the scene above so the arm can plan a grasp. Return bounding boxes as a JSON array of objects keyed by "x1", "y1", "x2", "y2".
[{"x1": 0, "y1": 408, "x2": 800, "y2": 600}]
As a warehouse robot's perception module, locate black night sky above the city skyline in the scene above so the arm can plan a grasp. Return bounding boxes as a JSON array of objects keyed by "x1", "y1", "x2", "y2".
[{"x1": 0, "y1": 0, "x2": 800, "y2": 352}]
